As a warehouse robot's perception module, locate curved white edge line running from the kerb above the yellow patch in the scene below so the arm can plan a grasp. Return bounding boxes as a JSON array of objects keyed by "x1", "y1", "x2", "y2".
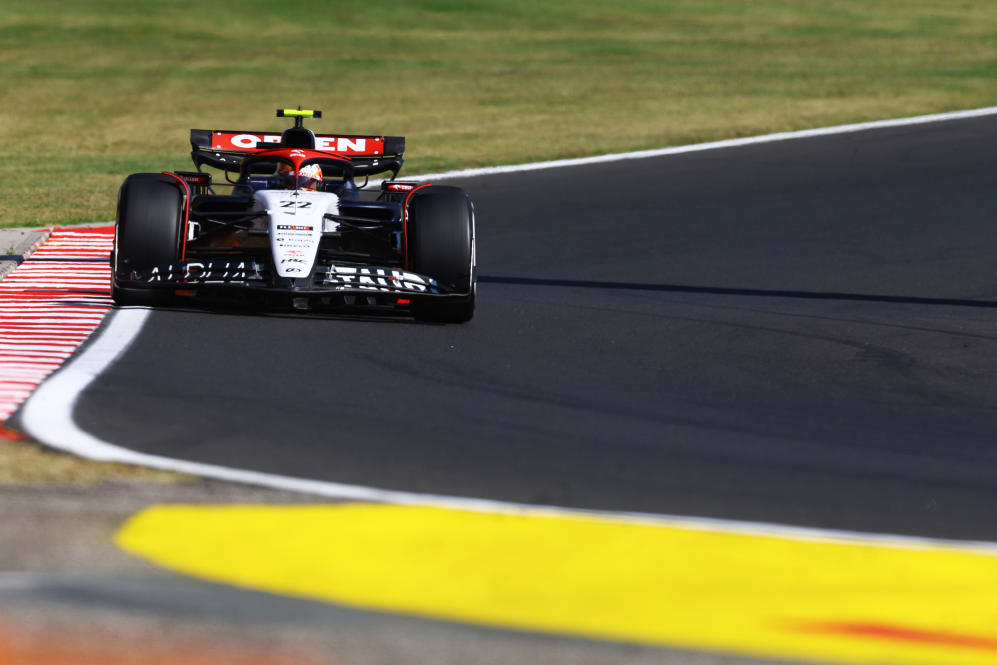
[{"x1": 13, "y1": 308, "x2": 997, "y2": 556}]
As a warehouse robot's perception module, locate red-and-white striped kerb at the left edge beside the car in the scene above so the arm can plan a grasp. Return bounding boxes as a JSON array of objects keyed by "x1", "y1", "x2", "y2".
[{"x1": 0, "y1": 226, "x2": 114, "y2": 423}]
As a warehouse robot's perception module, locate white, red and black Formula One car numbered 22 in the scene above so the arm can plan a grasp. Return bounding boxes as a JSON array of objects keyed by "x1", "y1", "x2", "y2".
[{"x1": 111, "y1": 109, "x2": 475, "y2": 323}]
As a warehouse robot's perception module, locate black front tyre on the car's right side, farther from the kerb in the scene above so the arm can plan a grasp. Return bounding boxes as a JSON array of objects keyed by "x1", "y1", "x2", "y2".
[{"x1": 406, "y1": 185, "x2": 476, "y2": 323}]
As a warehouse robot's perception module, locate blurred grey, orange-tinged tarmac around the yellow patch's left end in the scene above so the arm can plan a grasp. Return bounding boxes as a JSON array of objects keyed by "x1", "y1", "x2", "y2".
[{"x1": 0, "y1": 480, "x2": 800, "y2": 665}]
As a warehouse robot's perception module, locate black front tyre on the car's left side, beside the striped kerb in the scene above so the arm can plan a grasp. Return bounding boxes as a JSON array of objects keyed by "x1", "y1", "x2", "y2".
[{"x1": 111, "y1": 173, "x2": 185, "y2": 306}]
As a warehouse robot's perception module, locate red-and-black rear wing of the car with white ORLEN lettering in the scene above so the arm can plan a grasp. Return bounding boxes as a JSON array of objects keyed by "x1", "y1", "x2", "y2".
[{"x1": 190, "y1": 129, "x2": 405, "y2": 177}]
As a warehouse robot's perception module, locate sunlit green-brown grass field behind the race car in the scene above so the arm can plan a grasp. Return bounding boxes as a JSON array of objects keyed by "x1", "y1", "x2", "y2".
[{"x1": 0, "y1": 0, "x2": 997, "y2": 226}]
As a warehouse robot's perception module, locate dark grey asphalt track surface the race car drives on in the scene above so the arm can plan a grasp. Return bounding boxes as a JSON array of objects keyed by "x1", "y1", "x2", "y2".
[{"x1": 42, "y1": 111, "x2": 997, "y2": 539}]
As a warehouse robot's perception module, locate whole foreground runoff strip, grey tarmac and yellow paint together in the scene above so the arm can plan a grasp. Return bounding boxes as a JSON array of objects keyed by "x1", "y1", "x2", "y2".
[{"x1": 0, "y1": 474, "x2": 997, "y2": 665}]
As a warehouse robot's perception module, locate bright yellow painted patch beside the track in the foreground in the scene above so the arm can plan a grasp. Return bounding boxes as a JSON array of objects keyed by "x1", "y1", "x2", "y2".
[{"x1": 116, "y1": 503, "x2": 997, "y2": 665}]
